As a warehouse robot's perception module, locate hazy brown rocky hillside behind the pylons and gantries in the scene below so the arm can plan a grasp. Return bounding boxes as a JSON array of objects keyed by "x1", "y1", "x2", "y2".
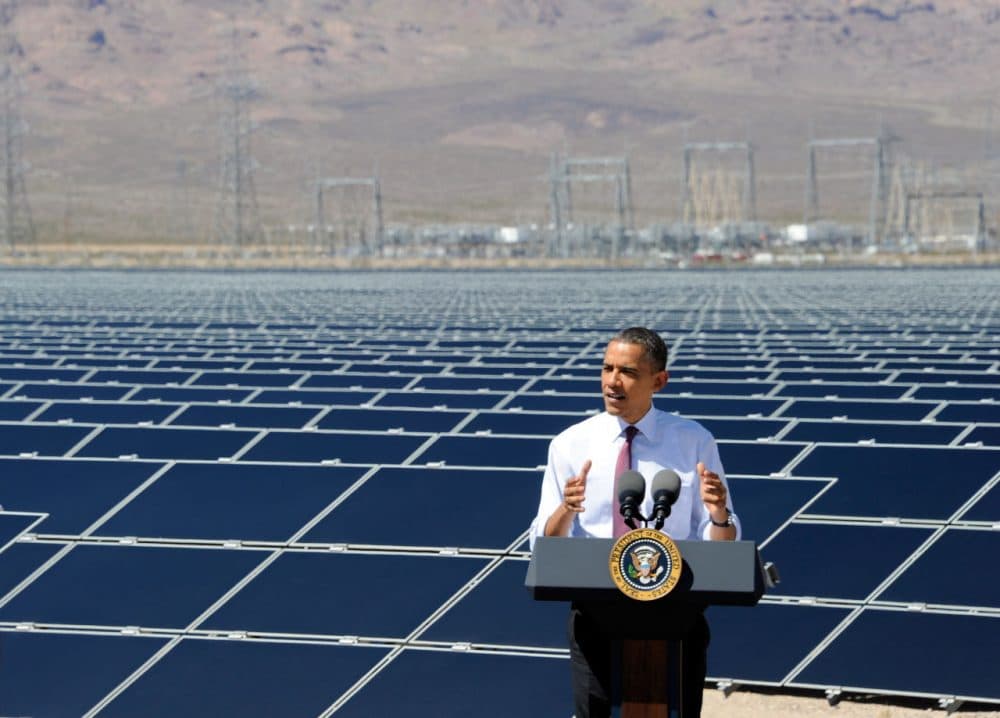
[{"x1": 7, "y1": 0, "x2": 1000, "y2": 236}]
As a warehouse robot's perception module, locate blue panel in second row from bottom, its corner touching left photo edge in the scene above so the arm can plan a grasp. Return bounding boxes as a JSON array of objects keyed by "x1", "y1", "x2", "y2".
[{"x1": 0, "y1": 544, "x2": 267, "y2": 629}]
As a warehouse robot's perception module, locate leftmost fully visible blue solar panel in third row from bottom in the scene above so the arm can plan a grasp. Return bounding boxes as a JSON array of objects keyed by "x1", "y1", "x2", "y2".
[{"x1": 96, "y1": 463, "x2": 364, "y2": 541}]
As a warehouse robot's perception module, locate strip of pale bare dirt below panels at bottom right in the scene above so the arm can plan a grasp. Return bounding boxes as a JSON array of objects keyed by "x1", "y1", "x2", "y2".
[{"x1": 702, "y1": 688, "x2": 1000, "y2": 718}]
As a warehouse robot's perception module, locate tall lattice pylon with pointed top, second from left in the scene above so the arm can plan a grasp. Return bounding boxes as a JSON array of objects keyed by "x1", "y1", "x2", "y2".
[{"x1": 215, "y1": 27, "x2": 264, "y2": 251}]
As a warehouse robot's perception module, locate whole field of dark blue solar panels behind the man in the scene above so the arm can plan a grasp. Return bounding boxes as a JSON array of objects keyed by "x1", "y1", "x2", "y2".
[{"x1": 0, "y1": 269, "x2": 1000, "y2": 716}]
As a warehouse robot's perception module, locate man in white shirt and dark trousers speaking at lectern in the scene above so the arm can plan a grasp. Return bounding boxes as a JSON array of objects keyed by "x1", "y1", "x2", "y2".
[{"x1": 531, "y1": 327, "x2": 740, "y2": 718}]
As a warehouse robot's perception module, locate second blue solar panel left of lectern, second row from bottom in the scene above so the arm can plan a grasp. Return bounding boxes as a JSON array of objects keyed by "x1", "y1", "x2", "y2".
[{"x1": 200, "y1": 551, "x2": 486, "y2": 639}]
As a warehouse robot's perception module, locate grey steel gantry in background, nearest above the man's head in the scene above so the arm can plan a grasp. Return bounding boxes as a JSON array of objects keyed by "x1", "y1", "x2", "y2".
[{"x1": 549, "y1": 154, "x2": 635, "y2": 258}]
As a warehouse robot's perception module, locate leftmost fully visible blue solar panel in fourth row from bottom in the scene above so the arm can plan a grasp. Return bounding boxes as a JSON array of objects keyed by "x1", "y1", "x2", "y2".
[{"x1": 76, "y1": 427, "x2": 257, "y2": 459}]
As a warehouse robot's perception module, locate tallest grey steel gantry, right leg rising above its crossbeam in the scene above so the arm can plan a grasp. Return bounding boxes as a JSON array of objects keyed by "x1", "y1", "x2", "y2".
[{"x1": 803, "y1": 123, "x2": 900, "y2": 246}]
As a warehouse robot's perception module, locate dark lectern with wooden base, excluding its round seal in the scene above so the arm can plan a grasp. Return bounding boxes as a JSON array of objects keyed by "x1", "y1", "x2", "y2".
[{"x1": 525, "y1": 537, "x2": 764, "y2": 718}]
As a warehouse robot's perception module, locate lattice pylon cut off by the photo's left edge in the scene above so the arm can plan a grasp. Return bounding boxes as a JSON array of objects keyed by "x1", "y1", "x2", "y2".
[{"x1": 0, "y1": 3, "x2": 35, "y2": 252}]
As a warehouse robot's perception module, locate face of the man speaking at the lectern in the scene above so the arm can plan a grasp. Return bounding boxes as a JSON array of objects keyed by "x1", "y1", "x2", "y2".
[{"x1": 601, "y1": 341, "x2": 667, "y2": 424}]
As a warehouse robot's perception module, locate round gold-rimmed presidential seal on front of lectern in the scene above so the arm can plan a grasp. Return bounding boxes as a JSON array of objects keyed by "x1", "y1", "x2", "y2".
[{"x1": 608, "y1": 529, "x2": 682, "y2": 601}]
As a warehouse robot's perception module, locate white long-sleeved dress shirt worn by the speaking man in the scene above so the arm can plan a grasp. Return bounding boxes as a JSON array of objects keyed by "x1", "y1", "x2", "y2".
[{"x1": 530, "y1": 407, "x2": 741, "y2": 548}]
